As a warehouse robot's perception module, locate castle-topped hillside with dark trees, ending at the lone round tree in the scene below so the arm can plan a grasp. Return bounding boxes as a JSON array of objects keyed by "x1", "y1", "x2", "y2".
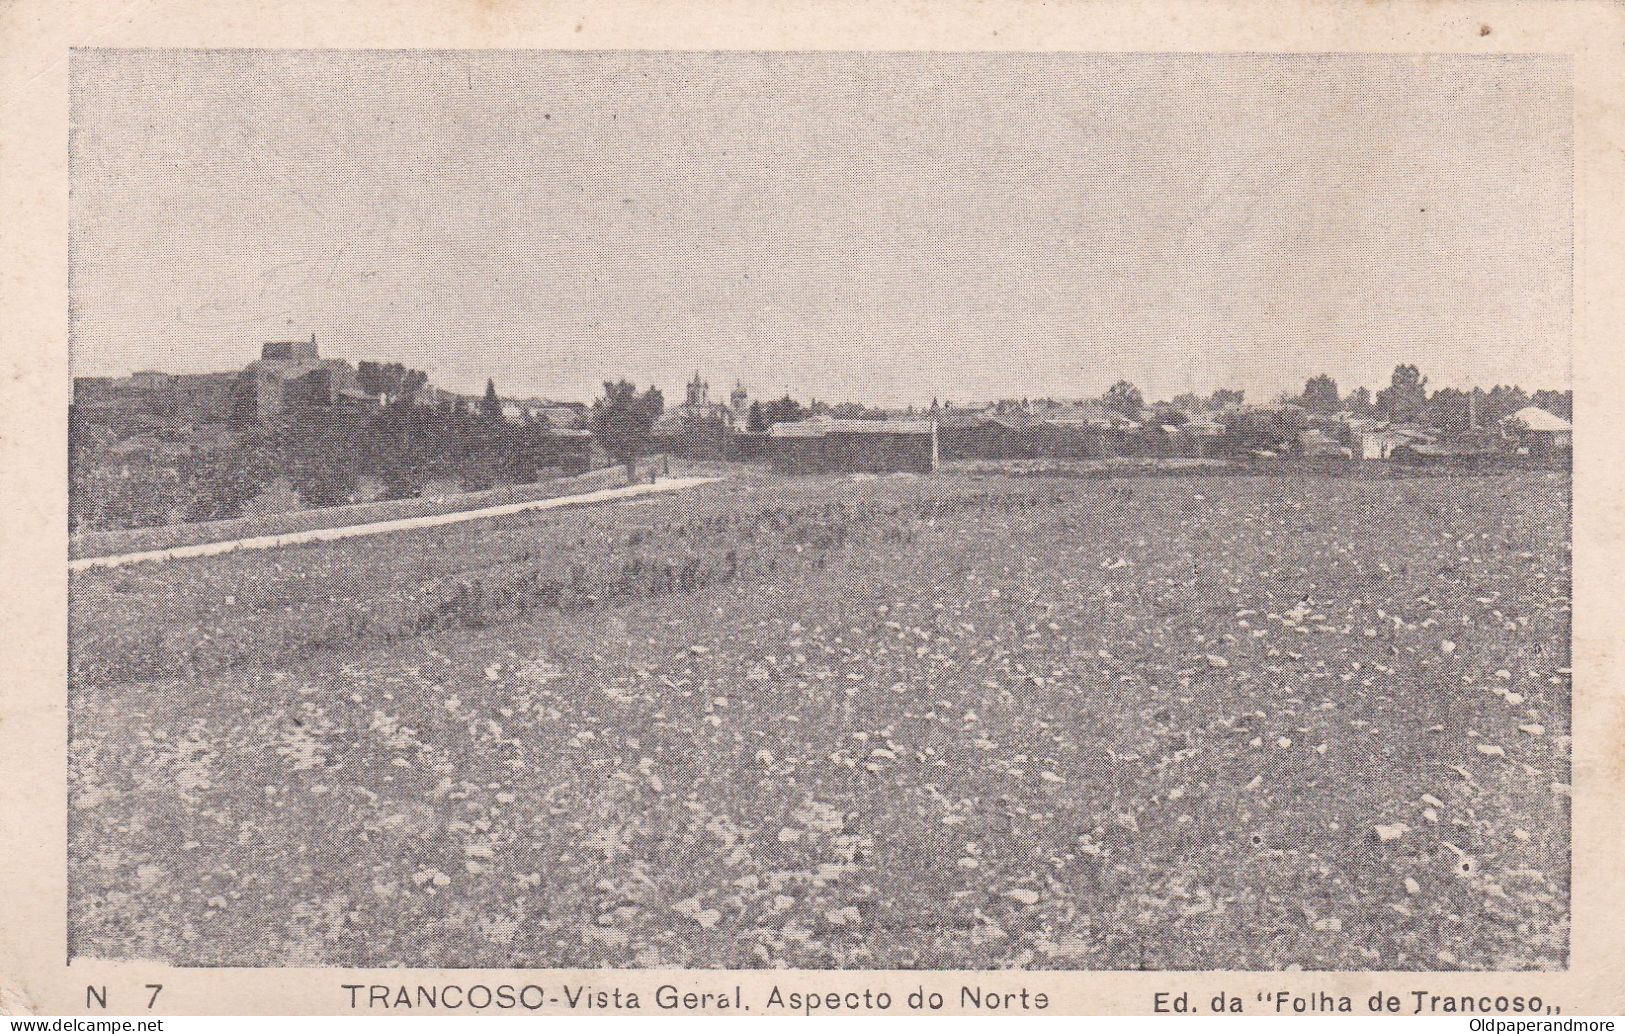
[{"x1": 68, "y1": 335, "x2": 605, "y2": 530}]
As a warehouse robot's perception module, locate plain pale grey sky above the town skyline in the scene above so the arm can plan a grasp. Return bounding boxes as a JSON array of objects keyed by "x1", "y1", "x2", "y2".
[{"x1": 72, "y1": 50, "x2": 1571, "y2": 403}]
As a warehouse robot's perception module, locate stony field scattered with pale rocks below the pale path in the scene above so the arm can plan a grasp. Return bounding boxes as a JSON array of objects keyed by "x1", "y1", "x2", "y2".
[{"x1": 70, "y1": 473, "x2": 1570, "y2": 969}]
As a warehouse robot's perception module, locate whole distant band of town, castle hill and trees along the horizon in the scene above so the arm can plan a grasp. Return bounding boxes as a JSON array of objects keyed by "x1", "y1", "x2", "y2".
[{"x1": 70, "y1": 335, "x2": 1573, "y2": 530}]
